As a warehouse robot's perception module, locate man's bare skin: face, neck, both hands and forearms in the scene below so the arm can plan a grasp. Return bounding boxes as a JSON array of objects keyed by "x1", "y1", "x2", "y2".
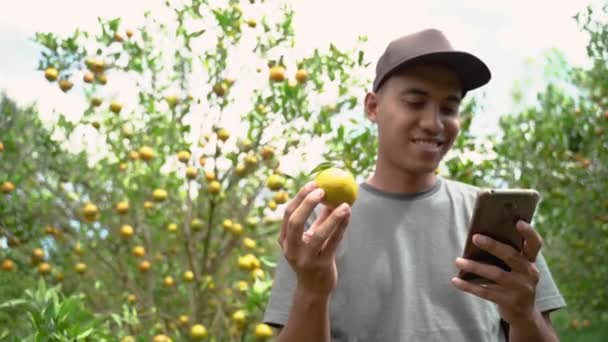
[{"x1": 278, "y1": 65, "x2": 558, "y2": 341}]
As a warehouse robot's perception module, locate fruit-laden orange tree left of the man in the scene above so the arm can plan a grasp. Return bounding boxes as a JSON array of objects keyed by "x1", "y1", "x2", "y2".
[{"x1": 0, "y1": 0, "x2": 368, "y2": 341}]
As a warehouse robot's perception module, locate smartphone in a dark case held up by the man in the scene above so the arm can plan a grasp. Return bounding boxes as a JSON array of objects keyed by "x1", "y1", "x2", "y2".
[{"x1": 457, "y1": 189, "x2": 540, "y2": 284}]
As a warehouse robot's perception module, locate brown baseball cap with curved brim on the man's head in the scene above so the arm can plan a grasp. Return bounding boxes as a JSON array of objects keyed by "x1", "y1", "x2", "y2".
[{"x1": 374, "y1": 29, "x2": 492, "y2": 93}]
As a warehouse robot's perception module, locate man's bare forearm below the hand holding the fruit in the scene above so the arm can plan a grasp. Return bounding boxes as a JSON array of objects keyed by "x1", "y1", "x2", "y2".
[{"x1": 277, "y1": 289, "x2": 331, "y2": 342}]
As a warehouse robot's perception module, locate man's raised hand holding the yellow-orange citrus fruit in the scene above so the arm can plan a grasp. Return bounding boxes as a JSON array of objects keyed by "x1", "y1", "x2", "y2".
[{"x1": 279, "y1": 182, "x2": 351, "y2": 296}]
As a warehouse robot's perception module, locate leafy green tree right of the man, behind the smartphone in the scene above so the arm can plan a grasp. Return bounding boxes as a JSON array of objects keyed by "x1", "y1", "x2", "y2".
[{"x1": 494, "y1": 3, "x2": 608, "y2": 325}]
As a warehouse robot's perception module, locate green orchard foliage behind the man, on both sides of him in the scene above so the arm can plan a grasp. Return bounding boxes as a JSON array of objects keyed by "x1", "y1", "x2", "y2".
[{"x1": 0, "y1": 1, "x2": 608, "y2": 341}]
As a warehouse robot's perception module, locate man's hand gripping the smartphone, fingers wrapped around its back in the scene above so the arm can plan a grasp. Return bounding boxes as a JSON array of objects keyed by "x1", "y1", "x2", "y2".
[{"x1": 452, "y1": 221, "x2": 542, "y2": 325}]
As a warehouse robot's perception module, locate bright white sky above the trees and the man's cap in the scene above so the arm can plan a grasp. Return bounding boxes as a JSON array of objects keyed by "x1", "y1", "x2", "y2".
[{"x1": 0, "y1": 0, "x2": 589, "y2": 144}]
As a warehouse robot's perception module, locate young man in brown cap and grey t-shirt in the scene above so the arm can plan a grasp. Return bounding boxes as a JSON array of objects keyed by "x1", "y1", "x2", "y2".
[{"x1": 264, "y1": 30, "x2": 565, "y2": 342}]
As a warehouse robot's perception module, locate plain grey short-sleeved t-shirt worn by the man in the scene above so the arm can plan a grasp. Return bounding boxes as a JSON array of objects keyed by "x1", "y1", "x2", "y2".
[{"x1": 264, "y1": 178, "x2": 565, "y2": 342}]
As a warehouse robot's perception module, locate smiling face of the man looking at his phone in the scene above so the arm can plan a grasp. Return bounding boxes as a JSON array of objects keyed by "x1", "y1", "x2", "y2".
[{"x1": 366, "y1": 65, "x2": 462, "y2": 175}]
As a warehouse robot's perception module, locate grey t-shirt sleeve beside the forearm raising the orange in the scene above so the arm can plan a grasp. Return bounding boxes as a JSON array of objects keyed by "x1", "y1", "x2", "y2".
[{"x1": 264, "y1": 207, "x2": 318, "y2": 327}]
